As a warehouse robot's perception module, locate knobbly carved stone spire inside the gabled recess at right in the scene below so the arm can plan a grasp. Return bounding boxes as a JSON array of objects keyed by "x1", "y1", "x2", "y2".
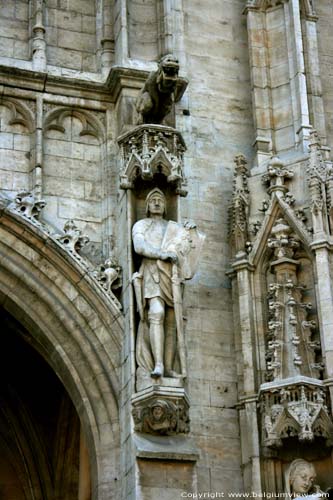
[{"x1": 266, "y1": 218, "x2": 324, "y2": 381}]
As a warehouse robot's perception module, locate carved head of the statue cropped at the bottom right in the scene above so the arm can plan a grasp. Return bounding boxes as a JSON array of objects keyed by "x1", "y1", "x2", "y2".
[{"x1": 288, "y1": 458, "x2": 316, "y2": 496}]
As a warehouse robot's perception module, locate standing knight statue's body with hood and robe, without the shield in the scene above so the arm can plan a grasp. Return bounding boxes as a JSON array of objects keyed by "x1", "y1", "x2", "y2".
[{"x1": 132, "y1": 188, "x2": 178, "y2": 377}]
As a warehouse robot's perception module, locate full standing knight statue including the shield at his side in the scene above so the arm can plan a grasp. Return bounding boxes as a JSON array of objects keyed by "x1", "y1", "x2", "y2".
[{"x1": 132, "y1": 188, "x2": 204, "y2": 378}]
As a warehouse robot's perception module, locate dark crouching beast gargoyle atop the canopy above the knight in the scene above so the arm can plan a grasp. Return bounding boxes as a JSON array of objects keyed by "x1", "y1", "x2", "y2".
[{"x1": 135, "y1": 54, "x2": 179, "y2": 125}]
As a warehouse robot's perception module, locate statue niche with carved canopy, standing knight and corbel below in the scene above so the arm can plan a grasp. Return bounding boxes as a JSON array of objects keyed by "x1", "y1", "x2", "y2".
[{"x1": 118, "y1": 116, "x2": 203, "y2": 436}]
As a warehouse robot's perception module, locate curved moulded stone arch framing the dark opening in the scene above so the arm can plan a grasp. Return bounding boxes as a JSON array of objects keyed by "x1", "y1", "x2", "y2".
[{"x1": 0, "y1": 206, "x2": 123, "y2": 500}]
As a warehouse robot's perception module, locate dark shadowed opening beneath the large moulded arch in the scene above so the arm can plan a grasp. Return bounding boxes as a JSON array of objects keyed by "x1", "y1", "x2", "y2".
[{"x1": 0, "y1": 309, "x2": 89, "y2": 500}]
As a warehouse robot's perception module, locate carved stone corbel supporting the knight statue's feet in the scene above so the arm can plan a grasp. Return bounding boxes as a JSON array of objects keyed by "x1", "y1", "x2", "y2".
[{"x1": 132, "y1": 388, "x2": 190, "y2": 435}]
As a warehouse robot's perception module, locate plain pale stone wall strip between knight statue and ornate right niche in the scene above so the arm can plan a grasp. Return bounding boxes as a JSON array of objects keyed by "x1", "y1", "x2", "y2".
[{"x1": 177, "y1": 1, "x2": 254, "y2": 491}]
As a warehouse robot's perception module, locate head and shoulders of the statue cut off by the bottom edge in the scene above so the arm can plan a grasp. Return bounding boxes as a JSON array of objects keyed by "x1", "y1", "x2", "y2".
[{"x1": 286, "y1": 458, "x2": 325, "y2": 500}]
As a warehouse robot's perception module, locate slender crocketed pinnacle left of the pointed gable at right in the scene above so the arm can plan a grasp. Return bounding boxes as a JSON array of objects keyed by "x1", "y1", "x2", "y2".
[{"x1": 230, "y1": 154, "x2": 250, "y2": 257}]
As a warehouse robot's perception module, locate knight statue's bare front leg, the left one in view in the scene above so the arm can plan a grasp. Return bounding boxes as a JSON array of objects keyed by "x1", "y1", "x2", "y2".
[{"x1": 148, "y1": 297, "x2": 165, "y2": 377}]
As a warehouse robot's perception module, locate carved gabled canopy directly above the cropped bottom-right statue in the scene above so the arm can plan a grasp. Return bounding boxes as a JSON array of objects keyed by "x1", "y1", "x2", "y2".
[{"x1": 260, "y1": 377, "x2": 333, "y2": 448}]
